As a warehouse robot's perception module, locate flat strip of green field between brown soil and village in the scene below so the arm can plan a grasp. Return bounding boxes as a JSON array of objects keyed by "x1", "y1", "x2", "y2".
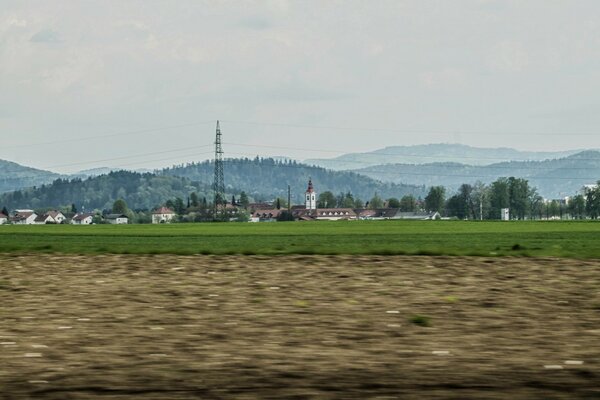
[{"x1": 0, "y1": 221, "x2": 600, "y2": 258}]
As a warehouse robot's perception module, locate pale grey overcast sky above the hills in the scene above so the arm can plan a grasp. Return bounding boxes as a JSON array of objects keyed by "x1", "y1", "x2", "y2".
[{"x1": 0, "y1": 0, "x2": 600, "y2": 172}]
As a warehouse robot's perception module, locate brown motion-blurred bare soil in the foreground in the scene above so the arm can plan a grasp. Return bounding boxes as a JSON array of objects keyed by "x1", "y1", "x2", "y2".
[{"x1": 0, "y1": 255, "x2": 600, "y2": 399}]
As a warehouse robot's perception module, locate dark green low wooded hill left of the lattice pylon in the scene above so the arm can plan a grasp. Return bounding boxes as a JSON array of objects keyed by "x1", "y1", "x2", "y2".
[{"x1": 0, "y1": 171, "x2": 211, "y2": 210}]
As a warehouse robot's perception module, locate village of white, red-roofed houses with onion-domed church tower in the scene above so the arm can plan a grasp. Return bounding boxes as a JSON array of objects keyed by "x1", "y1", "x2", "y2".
[{"x1": 0, "y1": 178, "x2": 441, "y2": 225}]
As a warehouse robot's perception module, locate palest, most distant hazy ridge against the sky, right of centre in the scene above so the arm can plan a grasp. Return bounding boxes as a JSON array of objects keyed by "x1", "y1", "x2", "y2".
[{"x1": 304, "y1": 143, "x2": 581, "y2": 170}]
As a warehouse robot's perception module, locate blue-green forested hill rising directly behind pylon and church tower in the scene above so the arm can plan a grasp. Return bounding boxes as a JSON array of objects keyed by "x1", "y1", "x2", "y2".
[{"x1": 162, "y1": 158, "x2": 427, "y2": 203}]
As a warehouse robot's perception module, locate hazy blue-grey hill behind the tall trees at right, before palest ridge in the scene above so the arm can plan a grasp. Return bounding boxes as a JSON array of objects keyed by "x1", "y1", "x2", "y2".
[{"x1": 355, "y1": 150, "x2": 600, "y2": 198}]
